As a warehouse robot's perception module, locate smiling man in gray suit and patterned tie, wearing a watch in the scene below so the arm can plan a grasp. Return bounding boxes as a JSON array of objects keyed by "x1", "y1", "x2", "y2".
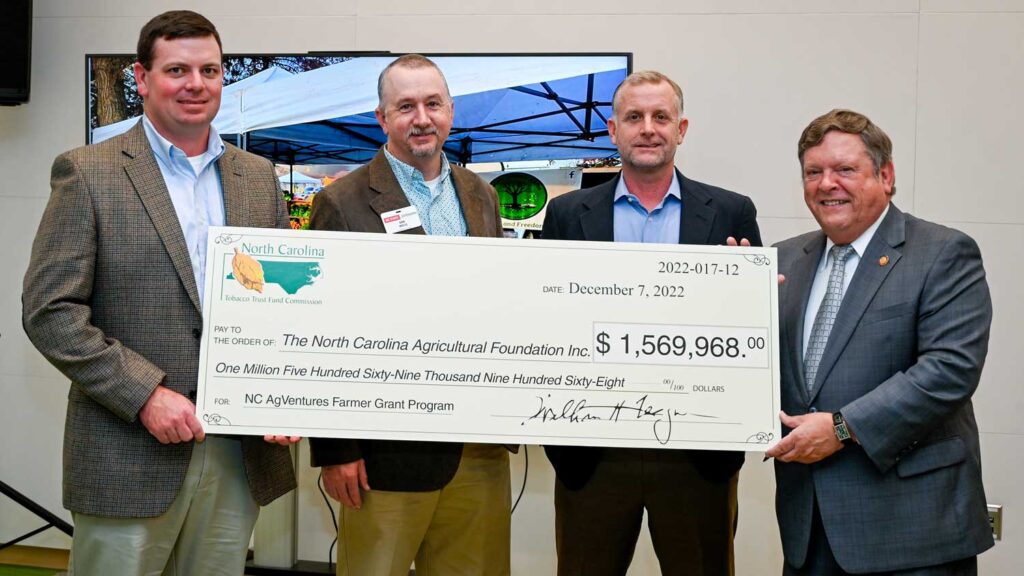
[{"x1": 767, "y1": 110, "x2": 993, "y2": 576}]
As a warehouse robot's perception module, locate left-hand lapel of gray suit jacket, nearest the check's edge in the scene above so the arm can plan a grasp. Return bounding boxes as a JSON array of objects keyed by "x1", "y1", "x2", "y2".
[{"x1": 779, "y1": 232, "x2": 825, "y2": 403}]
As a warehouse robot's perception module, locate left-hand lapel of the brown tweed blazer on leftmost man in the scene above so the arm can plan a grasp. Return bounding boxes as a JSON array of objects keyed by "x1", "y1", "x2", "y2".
[{"x1": 122, "y1": 122, "x2": 202, "y2": 312}]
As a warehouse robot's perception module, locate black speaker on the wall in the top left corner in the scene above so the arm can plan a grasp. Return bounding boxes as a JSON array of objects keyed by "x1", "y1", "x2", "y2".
[{"x1": 0, "y1": 0, "x2": 32, "y2": 106}]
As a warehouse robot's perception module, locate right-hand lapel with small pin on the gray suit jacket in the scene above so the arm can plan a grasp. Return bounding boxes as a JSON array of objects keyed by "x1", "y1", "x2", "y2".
[{"x1": 811, "y1": 204, "x2": 906, "y2": 399}]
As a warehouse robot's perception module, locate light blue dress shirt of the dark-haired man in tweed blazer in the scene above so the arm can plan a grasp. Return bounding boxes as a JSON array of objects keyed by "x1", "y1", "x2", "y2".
[{"x1": 142, "y1": 115, "x2": 225, "y2": 303}]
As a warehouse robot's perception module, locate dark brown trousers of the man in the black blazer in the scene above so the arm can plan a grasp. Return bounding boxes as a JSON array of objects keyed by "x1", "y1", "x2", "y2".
[{"x1": 555, "y1": 448, "x2": 738, "y2": 576}]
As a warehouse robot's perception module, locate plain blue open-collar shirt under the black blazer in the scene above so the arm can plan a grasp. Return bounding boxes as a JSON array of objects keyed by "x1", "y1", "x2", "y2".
[{"x1": 611, "y1": 170, "x2": 683, "y2": 244}]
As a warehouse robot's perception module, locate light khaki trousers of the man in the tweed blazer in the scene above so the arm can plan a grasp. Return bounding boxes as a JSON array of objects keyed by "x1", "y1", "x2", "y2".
[{"x1": 69, "y1": 436, "x2": 259, "y2": 576}]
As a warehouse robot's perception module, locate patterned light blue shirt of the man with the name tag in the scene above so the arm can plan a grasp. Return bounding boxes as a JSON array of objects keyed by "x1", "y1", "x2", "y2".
[{"x1": 384, "y1": 146, "x2": 466, "y2": 236}]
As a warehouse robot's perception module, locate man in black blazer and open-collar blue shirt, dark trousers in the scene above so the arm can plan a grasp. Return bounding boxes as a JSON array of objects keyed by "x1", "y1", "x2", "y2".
[{"x1": 542, "y1": 72, "x2": 761, "y2": 576}]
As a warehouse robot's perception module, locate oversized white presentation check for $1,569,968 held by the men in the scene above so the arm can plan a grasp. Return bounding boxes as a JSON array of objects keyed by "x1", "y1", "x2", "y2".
[{"x1": 197, "y1": 228, "x2": 779, "y2": 450}]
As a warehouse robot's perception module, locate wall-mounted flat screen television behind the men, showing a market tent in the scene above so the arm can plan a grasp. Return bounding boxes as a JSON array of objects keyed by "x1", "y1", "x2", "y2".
[{"x1": 86, "y1": 53, "x2": 632, "y2": 230}]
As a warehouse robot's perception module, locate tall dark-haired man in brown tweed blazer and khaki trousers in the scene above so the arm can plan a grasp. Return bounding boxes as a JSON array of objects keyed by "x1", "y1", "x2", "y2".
[{"x1": 23, "y1": 11, "x2": 295, "y2": 576}]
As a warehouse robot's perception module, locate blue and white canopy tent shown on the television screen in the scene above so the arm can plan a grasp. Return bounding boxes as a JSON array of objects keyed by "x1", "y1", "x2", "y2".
[{"x1": 92, "y1": 54, "x2": 631, "y2": 165}]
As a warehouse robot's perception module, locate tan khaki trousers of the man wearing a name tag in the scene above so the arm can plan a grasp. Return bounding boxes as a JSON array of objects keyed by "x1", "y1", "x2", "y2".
[{"x1": 338, "y1": 444, "x2": 512, "y2": 576}]
